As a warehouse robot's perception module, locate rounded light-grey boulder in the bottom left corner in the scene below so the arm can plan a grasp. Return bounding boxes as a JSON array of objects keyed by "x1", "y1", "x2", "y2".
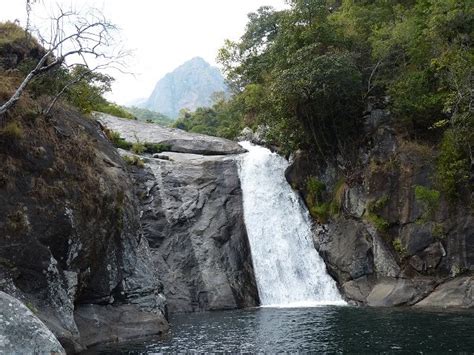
[{"x1": 0, "y1": 291, "x2": 66, "y2": 354}]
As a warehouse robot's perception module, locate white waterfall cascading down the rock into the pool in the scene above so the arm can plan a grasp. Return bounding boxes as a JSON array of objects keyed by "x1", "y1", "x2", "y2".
[{"x1": 239, "y1": 142, "x2": 345, "y2": 307}]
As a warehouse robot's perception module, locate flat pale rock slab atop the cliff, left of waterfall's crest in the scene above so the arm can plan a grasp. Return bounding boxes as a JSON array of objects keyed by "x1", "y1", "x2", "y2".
[{"x1": 95, "y1": 112, "x2": 245, "y2": 155}]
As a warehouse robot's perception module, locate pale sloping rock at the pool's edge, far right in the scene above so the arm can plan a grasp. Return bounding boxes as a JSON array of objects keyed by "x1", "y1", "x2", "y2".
[{"x1": 415, "y1": 276, "x2": 474, "y2": 308}]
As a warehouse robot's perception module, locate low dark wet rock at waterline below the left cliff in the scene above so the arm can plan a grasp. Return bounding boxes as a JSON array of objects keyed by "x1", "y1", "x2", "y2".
[{"x1": 75, "y1": 304, "x2": 168, "y2": 347}]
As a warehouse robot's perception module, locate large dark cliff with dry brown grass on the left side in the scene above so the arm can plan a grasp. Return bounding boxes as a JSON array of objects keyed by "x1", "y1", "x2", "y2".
[{"x1": 0, "y1": 110, "x2": 166, "y2": 352}]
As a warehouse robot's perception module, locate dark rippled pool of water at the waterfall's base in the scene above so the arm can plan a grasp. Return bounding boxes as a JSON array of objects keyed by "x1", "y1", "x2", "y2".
[{"x1": 94, "y1": 307, "x2": 474, "y2": 354}]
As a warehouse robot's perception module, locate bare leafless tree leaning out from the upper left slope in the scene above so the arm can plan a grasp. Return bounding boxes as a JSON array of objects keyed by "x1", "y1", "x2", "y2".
[{"x1": 0, "y1": 8, "x2": 128, "y2": 116}]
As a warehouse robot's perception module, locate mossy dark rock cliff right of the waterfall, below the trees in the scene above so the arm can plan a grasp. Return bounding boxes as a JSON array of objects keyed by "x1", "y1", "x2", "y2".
[{"x1": 287, "y1": 101, "x2": 474, "y2": 307}]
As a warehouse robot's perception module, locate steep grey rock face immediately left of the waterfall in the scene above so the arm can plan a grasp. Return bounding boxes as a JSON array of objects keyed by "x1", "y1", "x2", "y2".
[{"x1": 127, "y1": 153, "x2": 258, "y2": 312}]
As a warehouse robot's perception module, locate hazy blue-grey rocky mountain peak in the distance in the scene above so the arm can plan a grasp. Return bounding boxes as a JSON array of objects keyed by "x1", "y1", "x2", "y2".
[{"x1": 144, "y1": 57, "x2": 226, "y2": 118}]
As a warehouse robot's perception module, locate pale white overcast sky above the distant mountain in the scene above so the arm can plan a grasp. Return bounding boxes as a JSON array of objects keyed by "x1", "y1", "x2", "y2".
[{"x1": 0, "y1": 0, "x2": 285, "y2": 104}]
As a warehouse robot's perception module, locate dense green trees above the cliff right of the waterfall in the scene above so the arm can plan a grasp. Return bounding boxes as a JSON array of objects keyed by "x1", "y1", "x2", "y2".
[{"x1": 177, "y1": 0, "x2": 474, "y2": 197}]
